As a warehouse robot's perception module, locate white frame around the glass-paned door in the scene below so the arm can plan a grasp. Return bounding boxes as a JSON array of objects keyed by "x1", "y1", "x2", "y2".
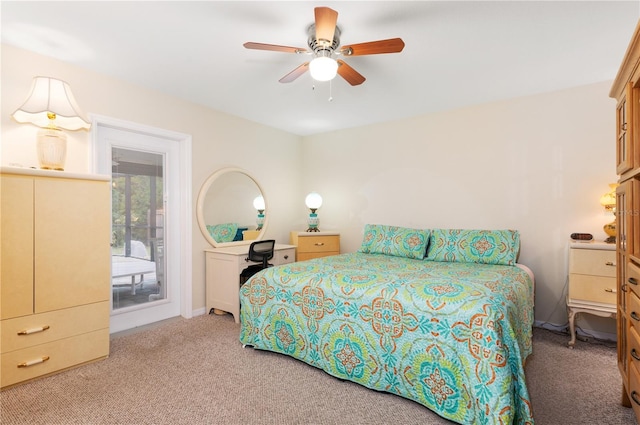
[{"x1": 89, "y1": 114, "x2": 193, "y2": 326}]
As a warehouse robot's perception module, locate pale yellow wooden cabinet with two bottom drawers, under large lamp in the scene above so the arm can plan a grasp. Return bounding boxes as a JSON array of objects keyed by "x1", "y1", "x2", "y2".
[{"x1": 0, "y1": 167, "x2": 111, "y2": 388}]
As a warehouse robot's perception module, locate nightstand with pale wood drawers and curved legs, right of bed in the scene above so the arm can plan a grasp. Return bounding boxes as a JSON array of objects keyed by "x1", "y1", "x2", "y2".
[{"x1": 567, "y1": 242, "x2": 616, "y2": 348}]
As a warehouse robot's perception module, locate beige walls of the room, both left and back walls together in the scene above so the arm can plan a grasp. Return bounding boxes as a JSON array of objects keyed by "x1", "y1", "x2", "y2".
[{"x1": 0, "y1": 46, "x2": 616, "y2": 334}]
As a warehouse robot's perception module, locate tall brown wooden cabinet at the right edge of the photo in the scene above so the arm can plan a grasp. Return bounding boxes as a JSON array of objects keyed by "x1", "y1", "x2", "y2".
[{"x1": 609, "y1": 22, "x2": 640, "y2": 420}]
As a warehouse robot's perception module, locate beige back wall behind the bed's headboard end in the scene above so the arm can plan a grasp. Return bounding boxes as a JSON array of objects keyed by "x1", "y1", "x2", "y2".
[{"x1": 303, "y1": 82, "x2": 617, "y2": 334}]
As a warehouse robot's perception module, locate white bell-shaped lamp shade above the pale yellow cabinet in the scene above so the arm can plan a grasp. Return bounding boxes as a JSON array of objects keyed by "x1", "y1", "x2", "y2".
[{"x1": 13, "y1": 77, "x2": 91, "y2": 130}]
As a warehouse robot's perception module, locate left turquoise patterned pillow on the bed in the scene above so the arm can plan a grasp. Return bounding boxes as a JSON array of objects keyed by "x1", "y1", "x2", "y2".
[{"x1": 359, "y1": 224, "x2": 429, "y2": 260}]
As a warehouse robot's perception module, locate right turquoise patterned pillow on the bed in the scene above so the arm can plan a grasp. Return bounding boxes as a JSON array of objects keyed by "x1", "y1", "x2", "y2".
[{"x1": 427, "y1": 229, "x2": 520, "y2": 266}]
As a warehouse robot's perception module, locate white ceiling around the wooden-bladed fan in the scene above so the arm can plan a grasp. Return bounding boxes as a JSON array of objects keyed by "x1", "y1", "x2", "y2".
[{"x1": 0, "y1": 0, "x2": 640, "y2": 135}]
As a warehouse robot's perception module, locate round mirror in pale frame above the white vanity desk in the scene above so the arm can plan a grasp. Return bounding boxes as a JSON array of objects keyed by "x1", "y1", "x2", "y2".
[{"x1": 196, "y1": 168, "x2": 269, "y2": 248}]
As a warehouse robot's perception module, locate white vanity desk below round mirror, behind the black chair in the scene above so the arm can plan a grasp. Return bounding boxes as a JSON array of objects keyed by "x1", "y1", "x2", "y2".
[{"x1": 205, "y1": 244, "x2": 296, "y2": 323}]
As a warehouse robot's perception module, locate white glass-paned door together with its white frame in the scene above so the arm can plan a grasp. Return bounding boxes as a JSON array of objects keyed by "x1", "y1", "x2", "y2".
[{"x1": 93, "y1": 118, "x2": 192, "y2": 333}]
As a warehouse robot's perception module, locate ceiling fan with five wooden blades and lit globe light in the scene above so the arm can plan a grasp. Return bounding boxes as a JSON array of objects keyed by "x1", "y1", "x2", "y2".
[{"x1": 243, "y1": 7, "x2": 404, "y2": 86}]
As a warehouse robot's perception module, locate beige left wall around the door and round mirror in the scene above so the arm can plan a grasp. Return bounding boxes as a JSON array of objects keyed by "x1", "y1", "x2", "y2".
[{"x1": 0, "y1": 45, "x2": 302, "y2": 313}]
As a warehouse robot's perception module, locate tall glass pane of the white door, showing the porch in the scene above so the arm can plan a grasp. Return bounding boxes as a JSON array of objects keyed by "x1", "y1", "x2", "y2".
[{"x1": 111, "y1": 147, "x2": 167, "y2": 311}]
